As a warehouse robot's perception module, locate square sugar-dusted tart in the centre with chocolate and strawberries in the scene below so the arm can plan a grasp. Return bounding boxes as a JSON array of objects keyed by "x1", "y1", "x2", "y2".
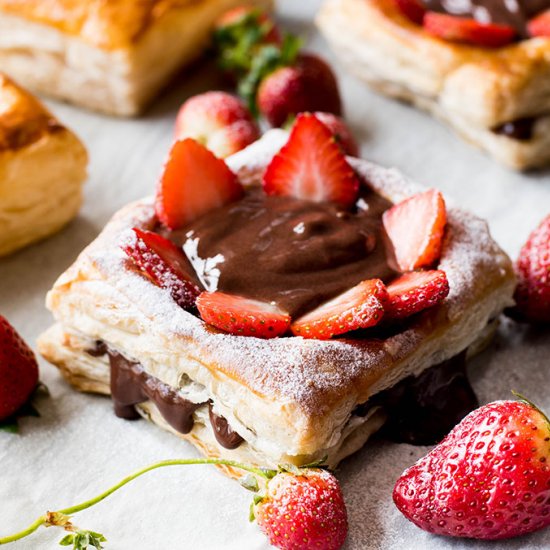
[{"x1": 39, "y1": 115, "x2": 514, "y2": 473}]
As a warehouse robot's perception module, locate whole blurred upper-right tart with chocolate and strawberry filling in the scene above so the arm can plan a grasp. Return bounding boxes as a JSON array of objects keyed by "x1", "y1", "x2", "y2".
[{"x1": 317, "y1": 0, "x2": 550, "y2": 169}]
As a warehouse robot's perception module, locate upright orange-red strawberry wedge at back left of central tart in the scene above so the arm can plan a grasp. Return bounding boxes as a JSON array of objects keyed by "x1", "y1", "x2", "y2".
[{"x1": 155, "y1": 138, "x2": 243, "y2": 233}]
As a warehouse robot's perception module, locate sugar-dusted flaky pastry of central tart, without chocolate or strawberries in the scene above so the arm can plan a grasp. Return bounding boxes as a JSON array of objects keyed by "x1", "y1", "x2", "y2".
[{"x1": 39, "y1": 131, "x2": 515, "y2": 470}]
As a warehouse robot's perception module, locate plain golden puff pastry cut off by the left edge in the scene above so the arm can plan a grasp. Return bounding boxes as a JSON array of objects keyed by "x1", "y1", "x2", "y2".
[{"x1": 0, "y1": 73, "x2": 87, "y2": 256}]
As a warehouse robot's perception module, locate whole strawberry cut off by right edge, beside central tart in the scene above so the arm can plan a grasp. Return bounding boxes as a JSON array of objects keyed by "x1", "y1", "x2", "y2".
[{"x1": 513, "y1": 214, "x2": 550, "y2": 323}]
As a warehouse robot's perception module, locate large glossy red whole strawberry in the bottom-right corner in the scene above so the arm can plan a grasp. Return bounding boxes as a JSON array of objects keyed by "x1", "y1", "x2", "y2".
[{"x1": 393, "y1": 401, "x2": 550, "y2": 539}]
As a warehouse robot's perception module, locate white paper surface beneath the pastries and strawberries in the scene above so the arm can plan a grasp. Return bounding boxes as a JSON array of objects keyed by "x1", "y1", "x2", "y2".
[{"x1": 0, "y1": 0, "x2": 550, "y2": 550}]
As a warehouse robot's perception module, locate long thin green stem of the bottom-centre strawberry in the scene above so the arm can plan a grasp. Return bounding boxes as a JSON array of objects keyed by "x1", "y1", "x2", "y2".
[{"x1": 0, "y1": 458, "x2": 277, "y2": 545}]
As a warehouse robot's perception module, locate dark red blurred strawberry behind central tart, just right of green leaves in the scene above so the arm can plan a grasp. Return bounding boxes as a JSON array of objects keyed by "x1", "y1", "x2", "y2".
[{"x1": 257, "y1": 54, "x2": 342, "y2": 126}]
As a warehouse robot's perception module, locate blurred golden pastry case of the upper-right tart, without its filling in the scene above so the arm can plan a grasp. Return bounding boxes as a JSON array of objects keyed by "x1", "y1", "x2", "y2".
[{"x1": 317, "y1": 0, "x2": 550, "y2": 169}]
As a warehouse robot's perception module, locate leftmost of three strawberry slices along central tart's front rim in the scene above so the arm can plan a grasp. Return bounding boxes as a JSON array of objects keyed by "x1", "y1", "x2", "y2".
[{"x1": 197, "y1": 292, "x2": 290, "y2": 338}]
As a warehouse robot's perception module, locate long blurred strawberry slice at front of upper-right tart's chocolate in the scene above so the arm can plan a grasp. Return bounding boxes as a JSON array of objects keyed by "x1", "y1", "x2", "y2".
[{"x1": 424, "y1": 11, "x2": 517, "y2": 48}]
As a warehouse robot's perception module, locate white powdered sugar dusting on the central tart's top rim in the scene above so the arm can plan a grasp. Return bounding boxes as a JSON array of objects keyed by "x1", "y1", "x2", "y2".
[{"x1": 54, "y1": 132, "x2": 511, "y2": 414}]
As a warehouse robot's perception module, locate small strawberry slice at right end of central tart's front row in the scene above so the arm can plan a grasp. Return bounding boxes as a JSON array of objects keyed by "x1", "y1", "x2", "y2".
[{"x1": 384, "y1": 270, "x2": 449, "y2": 320}]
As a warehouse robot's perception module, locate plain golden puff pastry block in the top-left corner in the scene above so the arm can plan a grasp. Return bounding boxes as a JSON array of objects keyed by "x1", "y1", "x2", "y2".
[{"x1": 0, "y1": 0, "x2": 270, "y2": 116}]
